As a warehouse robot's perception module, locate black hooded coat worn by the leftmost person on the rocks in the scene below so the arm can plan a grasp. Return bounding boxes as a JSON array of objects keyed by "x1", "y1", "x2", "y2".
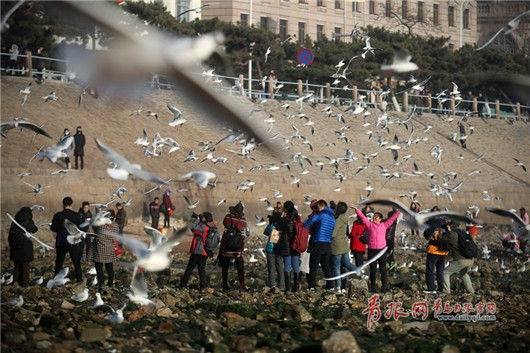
[{"x1": 7, "y1": 207, "x2": 39, "y2": 262}]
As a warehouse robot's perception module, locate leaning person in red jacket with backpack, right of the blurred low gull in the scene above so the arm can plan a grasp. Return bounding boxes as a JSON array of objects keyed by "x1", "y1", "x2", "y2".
[{"x1": 178, "y1": 212, "x2": 217, "y2": 290}]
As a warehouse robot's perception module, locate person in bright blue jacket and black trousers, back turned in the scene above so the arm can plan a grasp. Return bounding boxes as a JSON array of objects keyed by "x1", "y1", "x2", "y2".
[{"x1": 304, "y1": 200, "x2": 335, "y2": 292}]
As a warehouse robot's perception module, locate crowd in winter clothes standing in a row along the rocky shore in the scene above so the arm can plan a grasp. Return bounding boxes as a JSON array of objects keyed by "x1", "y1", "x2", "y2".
[{"x1": 8, "y1": 195, "x2": 528, "y2": 294}]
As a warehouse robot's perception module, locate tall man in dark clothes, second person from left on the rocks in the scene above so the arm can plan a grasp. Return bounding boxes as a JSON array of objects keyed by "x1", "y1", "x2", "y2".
[{"x1": 50, "y1": 196, "x2": 83, "y2": 283}]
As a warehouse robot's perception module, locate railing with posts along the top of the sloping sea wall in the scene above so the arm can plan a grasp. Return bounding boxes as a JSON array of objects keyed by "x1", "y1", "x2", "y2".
[{"x1": 0, "y1": 53, "x2": 530, "y2": 120}]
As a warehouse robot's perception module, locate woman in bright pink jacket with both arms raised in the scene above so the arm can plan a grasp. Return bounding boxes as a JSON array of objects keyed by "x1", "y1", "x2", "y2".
[{"x1": 354, "y1": 208, "x2": 400, "y2": 293}]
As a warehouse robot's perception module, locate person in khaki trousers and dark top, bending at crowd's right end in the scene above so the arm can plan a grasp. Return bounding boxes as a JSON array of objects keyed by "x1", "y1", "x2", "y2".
[{"x1": 442, "y1": 223, "x2": 475, "y2": 294}]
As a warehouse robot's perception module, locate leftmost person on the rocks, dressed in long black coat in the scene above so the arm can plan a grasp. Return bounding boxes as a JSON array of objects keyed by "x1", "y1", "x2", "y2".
[{"x1": 7, "y1": 207, "x2": 39, "y2": 287}]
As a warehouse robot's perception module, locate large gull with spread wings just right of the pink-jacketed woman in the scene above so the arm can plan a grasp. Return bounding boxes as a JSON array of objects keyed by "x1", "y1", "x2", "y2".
[{"x1": 358, "y1": 199, "x2": 482, "y2": 230}]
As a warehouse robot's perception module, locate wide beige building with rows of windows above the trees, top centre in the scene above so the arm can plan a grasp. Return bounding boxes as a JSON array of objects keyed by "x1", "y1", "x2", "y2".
[{"x1": 202, "y1": 0, "x2": 477, "y2": 48}]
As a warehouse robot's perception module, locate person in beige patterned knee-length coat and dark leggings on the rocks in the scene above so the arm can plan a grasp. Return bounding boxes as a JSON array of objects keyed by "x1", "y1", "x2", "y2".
[{"x1": 89, "y1": 210, "x2": 119, "y2": 292}]
